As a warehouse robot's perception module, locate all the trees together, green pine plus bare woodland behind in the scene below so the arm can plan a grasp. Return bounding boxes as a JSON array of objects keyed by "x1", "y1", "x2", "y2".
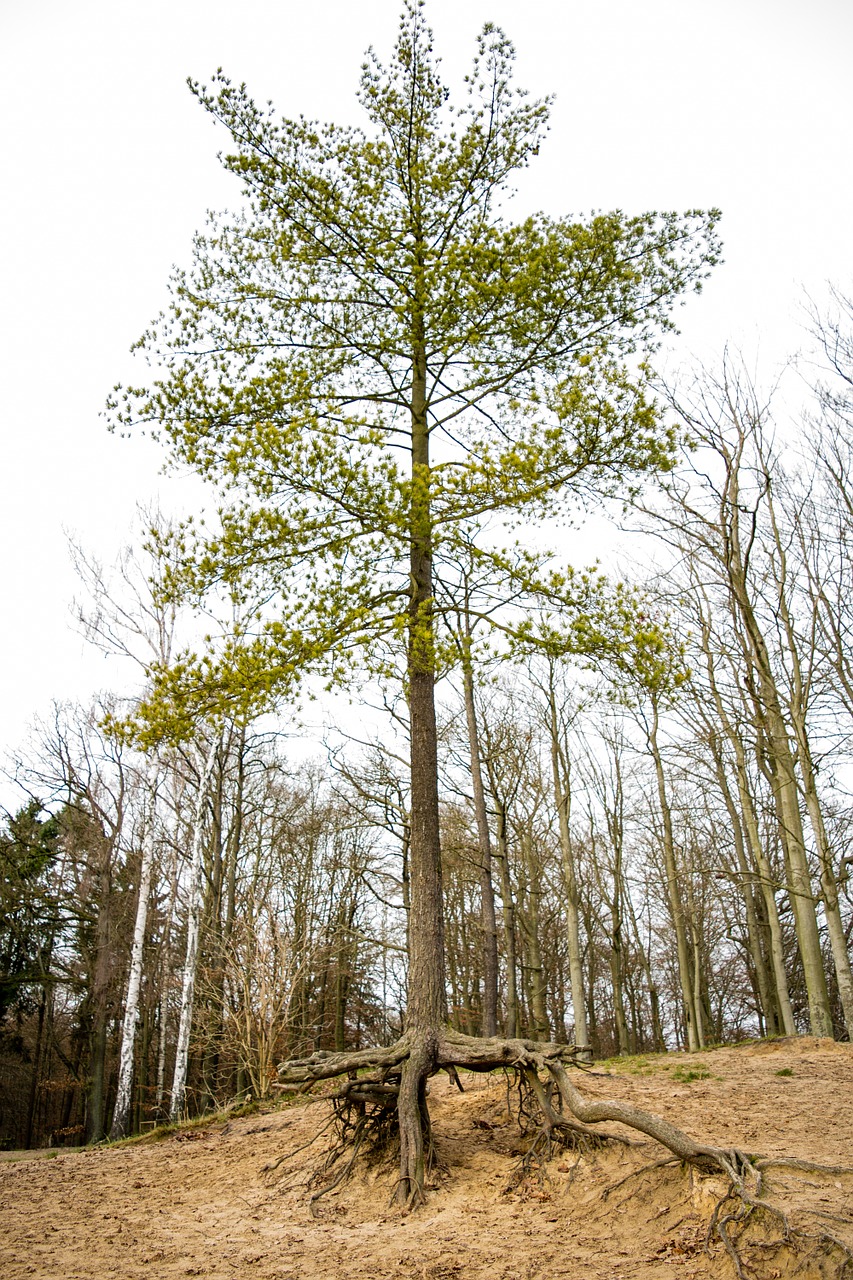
[{"x1": 0, "y1": 4, "x2": 853, "y2": 1203}]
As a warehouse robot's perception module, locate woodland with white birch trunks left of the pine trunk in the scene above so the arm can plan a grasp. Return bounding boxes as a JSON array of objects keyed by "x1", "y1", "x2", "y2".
[{"x1": 0, "y1": 708, "x2": 400, "y2": 1146}]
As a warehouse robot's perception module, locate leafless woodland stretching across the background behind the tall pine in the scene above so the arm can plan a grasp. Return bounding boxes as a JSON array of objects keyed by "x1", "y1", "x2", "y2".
[{"x1": 0, "y1": 308, "x2": 853, "y2": 1146}]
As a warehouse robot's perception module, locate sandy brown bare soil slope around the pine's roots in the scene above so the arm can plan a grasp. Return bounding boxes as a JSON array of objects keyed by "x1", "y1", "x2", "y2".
[{"x1": 0, "y1": 1038, "x2": 853, "y2": 1280}]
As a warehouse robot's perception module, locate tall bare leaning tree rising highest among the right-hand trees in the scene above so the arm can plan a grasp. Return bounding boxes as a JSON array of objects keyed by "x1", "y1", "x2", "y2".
[{"x1": 640, "y1": 371, "x2": 835, "y2": 1036}]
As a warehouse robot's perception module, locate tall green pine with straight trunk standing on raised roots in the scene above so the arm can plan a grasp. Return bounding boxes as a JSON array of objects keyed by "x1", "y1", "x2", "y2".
[{"x1": 111, "y1": 0, "x2": 717, "y2": 1202}]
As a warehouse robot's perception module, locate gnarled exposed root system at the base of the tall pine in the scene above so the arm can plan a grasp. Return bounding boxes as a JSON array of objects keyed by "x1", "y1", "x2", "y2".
[{"x1": 274, "y1": 1029, "x2": 853, "y2": 1280}]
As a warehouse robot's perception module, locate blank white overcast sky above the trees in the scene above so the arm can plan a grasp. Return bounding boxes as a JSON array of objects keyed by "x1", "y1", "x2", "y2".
[{"x1": 0, "y1": 0, "x2": 853, "y2": 778}]
